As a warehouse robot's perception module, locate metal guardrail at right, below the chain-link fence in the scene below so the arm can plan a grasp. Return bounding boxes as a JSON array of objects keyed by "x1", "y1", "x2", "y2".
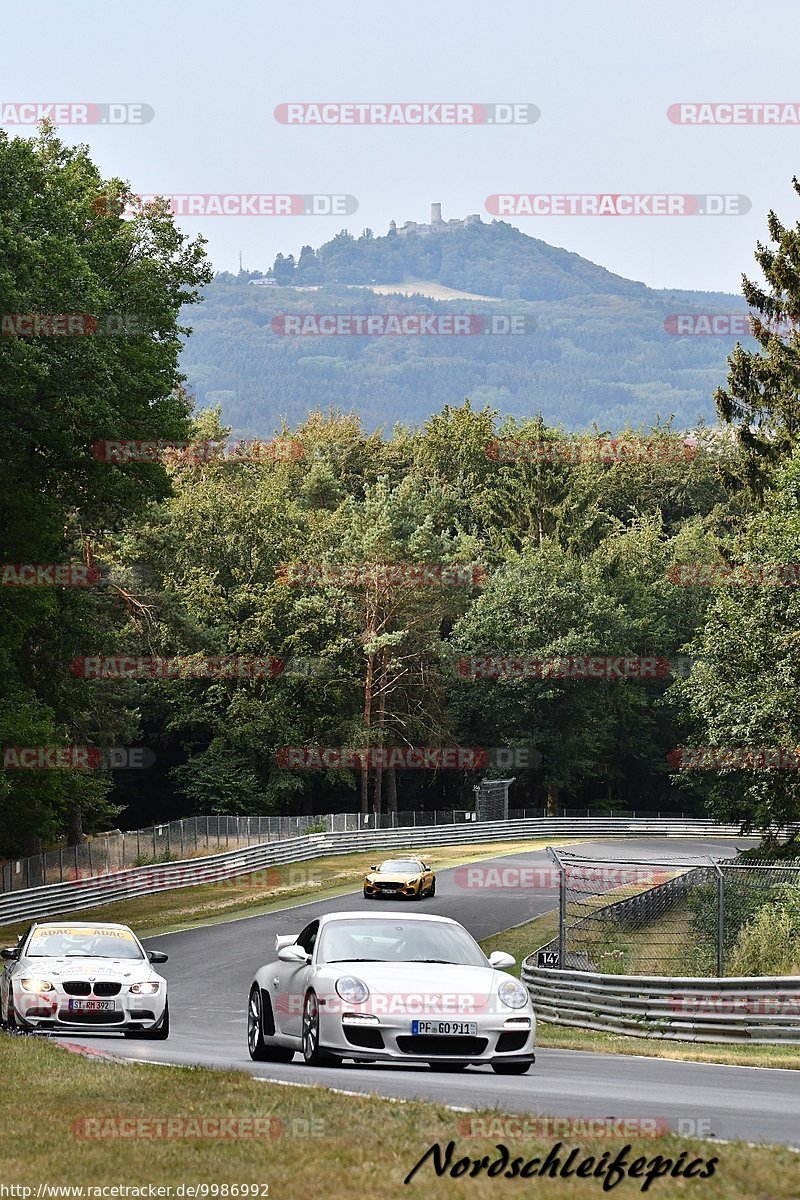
[{"x1": 522, "y1": 955, "x2": 800, "y2": 1045}]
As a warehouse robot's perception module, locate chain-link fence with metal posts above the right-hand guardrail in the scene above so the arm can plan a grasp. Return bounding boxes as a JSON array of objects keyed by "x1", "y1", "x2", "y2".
[{"x1": 540, "y1": 850, "x2": 800, "y2": 977}]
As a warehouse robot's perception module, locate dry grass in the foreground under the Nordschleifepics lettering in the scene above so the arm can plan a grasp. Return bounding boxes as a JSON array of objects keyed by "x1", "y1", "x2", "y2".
[{"x1": 0, "y1": 1034, "x2": 800, "y2": 1200}]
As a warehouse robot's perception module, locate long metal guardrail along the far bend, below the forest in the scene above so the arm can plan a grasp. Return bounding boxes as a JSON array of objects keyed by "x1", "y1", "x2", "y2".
[{"x1": 0, "y1": 817, "x2": 740, "y2": 925}]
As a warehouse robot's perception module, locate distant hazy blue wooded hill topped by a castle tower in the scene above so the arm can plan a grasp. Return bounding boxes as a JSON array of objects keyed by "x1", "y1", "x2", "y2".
[{"x1": 182, "y1": 221, "x2": 746, "y2": 437}]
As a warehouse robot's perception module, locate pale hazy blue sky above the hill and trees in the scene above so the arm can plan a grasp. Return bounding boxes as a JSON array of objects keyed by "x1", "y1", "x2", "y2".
[{"x1": 0, "y1": 0, "x2": 800, "y2": 292}]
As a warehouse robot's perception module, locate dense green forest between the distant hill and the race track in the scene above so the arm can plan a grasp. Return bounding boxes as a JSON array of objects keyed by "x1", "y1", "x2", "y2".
[{"x1": 0, "y1": 128, "x2": 800, "y2": 853}]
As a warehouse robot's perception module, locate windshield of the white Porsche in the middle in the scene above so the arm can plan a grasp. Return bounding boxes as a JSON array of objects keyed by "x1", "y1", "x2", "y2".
[{"x1": 318, "y1": 917, "x2": 487, "y2": 967}]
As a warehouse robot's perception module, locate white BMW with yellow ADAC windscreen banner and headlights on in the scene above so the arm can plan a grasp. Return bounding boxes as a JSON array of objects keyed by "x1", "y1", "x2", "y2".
[{"x1": 0, "y1": 920, "x2": 169, "y2": 1040}]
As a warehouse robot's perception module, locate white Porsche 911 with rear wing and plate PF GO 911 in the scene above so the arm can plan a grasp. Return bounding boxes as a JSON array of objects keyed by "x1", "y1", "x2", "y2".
[{"x1": 247, "y1": 912, "x2": 536, "y2": 1075}]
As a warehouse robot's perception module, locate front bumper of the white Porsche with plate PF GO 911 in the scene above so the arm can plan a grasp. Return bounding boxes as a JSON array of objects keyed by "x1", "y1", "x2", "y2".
[{"x1": 320, "y1": 1008, "x2": 536, "y2": 1063}]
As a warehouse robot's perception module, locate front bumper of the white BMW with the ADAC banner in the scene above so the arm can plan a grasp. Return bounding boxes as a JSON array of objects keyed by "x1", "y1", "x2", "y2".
[{"x1": 13, "y1": 988, "x2": 167, "y2": 1033}]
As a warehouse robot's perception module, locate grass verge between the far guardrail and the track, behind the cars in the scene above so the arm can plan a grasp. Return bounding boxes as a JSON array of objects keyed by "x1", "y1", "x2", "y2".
[{"x1": 0, "y1": 838, "x2": 576, "y2": 942}]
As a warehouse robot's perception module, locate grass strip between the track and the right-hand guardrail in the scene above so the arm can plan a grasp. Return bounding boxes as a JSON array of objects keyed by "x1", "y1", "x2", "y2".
[{"x1": 481, "y1": 912, "x2": 800, "y2": 1070}]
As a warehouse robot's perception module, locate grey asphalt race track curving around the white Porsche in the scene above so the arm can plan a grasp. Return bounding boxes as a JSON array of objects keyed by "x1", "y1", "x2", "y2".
[{"x1": 54, "y1": 838, "x2": 800, "y2": 1148}]
